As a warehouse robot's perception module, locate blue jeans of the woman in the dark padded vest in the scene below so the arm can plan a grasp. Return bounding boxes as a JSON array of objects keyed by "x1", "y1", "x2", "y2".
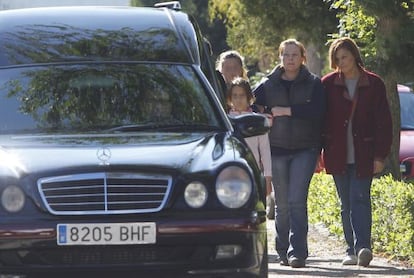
[{"x1": 272, "y1": 148, "x2": 319, "y2": 259}]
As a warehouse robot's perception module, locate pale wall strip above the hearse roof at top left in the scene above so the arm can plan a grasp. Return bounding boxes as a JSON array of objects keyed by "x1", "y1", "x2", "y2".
[{"x1": 0, "y1": 0, "x2": 129, "y2": 10}]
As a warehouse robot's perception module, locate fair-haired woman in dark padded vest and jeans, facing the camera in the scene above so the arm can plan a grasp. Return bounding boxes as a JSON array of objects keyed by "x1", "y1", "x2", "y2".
[{"x1": 254, "y1": 39, "x2": 325, "y2": 267}]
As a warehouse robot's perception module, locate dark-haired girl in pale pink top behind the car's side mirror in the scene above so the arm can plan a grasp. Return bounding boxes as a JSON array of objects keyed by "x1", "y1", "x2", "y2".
[{"x1": 228, "y1": 77, "x2": 272, "y2": 196}]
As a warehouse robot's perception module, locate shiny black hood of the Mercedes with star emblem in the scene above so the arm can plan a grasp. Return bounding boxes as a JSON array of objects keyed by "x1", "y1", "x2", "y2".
[{"x1": 0, "y1": 133, "x2": 234, "y2": 175}]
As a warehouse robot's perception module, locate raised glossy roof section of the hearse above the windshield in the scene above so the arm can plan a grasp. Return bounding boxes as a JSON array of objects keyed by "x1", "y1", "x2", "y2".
[{"x1": 0, "y1": 6, "x2": 199, "y2": 67}]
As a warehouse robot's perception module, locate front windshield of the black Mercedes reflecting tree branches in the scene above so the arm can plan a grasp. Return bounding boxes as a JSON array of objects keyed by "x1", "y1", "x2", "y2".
[{"x1": 0, "y1": 63, "x2": 222, "y2": 134}]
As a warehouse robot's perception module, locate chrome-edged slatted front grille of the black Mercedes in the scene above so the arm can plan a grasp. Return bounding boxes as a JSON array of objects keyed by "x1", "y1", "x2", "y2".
[{"x1": 38, "y1": 172, "x2": 172, "y2": 215}]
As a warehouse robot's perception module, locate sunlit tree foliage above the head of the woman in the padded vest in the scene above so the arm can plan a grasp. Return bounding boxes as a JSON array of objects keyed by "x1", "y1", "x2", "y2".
[{"x1": 209, "y1": 0, "x2": 338, "y2": 74}]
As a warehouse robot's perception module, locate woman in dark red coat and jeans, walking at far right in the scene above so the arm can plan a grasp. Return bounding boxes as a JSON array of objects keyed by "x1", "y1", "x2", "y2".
[{"x1": 322, "y1": 37, "x2": 392, "y2": 266}]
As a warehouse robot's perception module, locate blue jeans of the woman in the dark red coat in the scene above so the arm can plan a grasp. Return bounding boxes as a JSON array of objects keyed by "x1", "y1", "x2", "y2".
[{"x1": 333, "y1": 164, "x2": 372, "y2": 255}]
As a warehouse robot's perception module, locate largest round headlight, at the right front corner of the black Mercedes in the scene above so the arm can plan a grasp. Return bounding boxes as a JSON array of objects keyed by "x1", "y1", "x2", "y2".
[{"x1": 216, "y1": 166, "x2": 252, "y2": 208}]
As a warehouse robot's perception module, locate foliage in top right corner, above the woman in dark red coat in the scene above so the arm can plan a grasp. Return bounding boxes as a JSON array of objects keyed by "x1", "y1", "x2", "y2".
[{"x1": 327, "y1": 0, "x2": 414, "y2": 82}]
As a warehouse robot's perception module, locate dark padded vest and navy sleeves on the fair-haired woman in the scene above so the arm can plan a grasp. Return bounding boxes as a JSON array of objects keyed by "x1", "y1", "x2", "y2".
[{"x1": 255, "y1": 66, "x2": 326, "y2": 150}]
